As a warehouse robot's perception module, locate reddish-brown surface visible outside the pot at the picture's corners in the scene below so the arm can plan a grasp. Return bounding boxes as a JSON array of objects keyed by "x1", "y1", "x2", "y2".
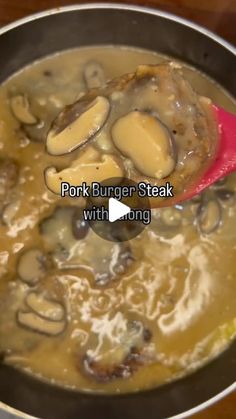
[{"x1": 0, "y1": 0, "x2": 236, "y2": 419}]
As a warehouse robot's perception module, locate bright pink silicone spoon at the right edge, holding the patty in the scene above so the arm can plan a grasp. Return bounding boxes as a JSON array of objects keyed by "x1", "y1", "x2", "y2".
[{"x1": 178, "y1": 105, "x2": 236, "y2": 201}]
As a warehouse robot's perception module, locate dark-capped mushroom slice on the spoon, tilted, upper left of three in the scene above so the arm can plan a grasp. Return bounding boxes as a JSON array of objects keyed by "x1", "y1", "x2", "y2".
[{"x1": 46, "y1": 96, "x2": 110, "y2": 156}]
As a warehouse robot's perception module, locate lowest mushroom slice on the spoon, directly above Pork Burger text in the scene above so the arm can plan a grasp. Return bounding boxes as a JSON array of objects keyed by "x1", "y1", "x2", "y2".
[{"x1": 45, "y1": 154, "x2": 124, "y2": 194}]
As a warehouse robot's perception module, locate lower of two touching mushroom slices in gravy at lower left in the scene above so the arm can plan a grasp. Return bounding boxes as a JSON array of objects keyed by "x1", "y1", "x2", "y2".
[{"x1": 16, "y1": 310, "x2": 66, "y2": 336}]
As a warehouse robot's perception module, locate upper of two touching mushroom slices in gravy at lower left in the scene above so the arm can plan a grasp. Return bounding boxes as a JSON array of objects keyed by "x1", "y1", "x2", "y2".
[{"x1": 25, "y1": 292, "x2": 65, "y2": 321}]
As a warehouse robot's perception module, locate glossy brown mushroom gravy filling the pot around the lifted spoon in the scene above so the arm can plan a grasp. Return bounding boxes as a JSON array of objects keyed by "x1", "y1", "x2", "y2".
[{"x1": 0, "y1": 47, "x2": 236, "y2": 393}]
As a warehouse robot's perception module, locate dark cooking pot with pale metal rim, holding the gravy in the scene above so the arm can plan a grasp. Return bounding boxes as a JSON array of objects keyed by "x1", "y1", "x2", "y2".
[{"x1": 0, "y1": 4, "x2": 236, "y2": 419}]
